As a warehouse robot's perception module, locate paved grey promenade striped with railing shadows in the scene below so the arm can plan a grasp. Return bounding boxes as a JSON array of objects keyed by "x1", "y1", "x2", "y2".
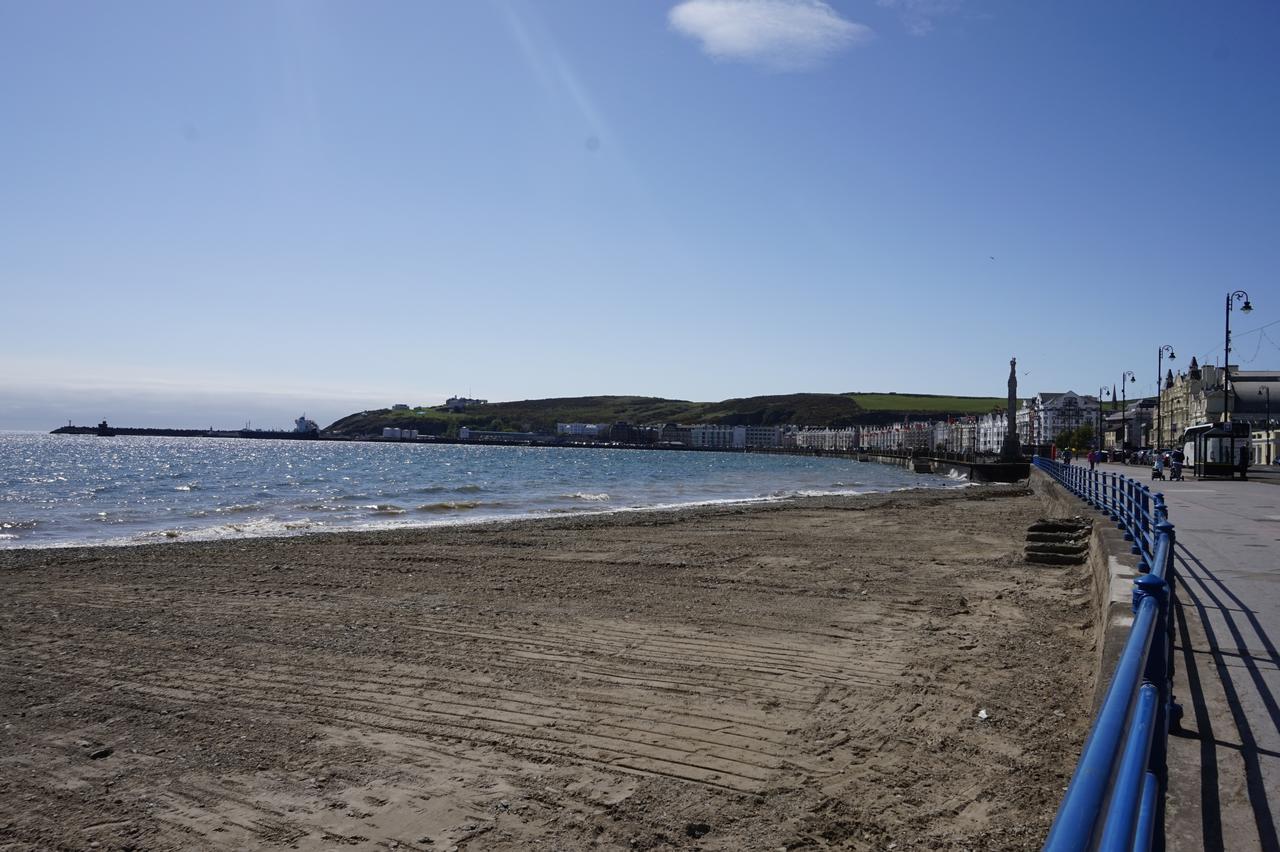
[{"x1": 1100, "y1": 464, "x2": 1280, "y2": 852}]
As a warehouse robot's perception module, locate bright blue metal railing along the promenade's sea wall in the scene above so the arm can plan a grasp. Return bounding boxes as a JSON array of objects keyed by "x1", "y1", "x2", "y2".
[{"x1": 1032, "y1": 457, "x2": 1179, "y2": 852}]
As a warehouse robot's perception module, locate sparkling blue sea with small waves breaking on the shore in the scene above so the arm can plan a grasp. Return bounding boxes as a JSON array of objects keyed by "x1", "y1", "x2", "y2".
[{"x1": 0, "y1": 432, "x2": 966, "y2": 549}]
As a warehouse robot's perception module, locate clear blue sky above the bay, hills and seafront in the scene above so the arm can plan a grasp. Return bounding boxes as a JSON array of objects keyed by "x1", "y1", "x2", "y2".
[{"x1": 0, "y1": 0, "x2": 1280, "y2": 429}]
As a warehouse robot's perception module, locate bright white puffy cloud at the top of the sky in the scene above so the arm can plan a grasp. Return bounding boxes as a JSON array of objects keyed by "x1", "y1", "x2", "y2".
[{"x1": 667, "y1": 0, "x2": 872, "y2": 70}]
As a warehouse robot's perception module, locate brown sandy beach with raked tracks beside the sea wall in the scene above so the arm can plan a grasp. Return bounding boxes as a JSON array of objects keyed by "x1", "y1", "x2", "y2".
[{"x1": 0, "y1": 487, "x2": 1094, "y2": 849}]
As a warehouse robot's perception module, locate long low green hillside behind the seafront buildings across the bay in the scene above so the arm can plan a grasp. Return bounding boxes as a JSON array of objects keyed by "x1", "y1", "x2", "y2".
[{"x1": 325, "y1": 394, "x2": 1001, "y2": 435}]
